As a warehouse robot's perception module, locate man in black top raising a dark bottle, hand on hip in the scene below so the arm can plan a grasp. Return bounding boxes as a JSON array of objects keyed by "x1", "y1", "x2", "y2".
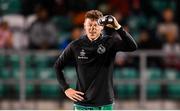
[{"x1": 55, "y1": 10, "x2": 137, "y2": 110}]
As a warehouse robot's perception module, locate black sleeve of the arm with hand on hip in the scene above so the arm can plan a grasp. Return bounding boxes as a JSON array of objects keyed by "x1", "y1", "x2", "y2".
[{"x1": 54, "y1": 43, "x2": 74, "y2": 91}]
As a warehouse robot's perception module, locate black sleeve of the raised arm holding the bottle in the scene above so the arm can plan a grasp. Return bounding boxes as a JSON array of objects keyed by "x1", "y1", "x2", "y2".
[{"x1": 114, "y1": 27, "x2": 138, "y2": 51}]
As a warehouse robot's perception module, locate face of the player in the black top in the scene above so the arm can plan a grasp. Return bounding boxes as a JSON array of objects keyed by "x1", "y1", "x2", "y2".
[{"x1": 84, "y1": 18, "x2": 103, "y2": 40}]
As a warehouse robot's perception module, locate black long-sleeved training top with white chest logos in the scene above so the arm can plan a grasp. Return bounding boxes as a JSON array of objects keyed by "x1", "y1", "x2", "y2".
[{"x1": 54, "y1": 27, "x2": 137, "y2": 106}]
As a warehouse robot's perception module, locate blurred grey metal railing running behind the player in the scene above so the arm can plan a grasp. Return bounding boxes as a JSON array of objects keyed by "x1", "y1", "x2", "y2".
[{"x1": 0, "y1": 50, "x2": 180, "y2": 109}]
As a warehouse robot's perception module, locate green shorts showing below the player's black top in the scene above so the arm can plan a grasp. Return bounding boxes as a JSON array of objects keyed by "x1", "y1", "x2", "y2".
[{"x1": 74, "y1": 104, "x2": 113, "y2": 111}]
